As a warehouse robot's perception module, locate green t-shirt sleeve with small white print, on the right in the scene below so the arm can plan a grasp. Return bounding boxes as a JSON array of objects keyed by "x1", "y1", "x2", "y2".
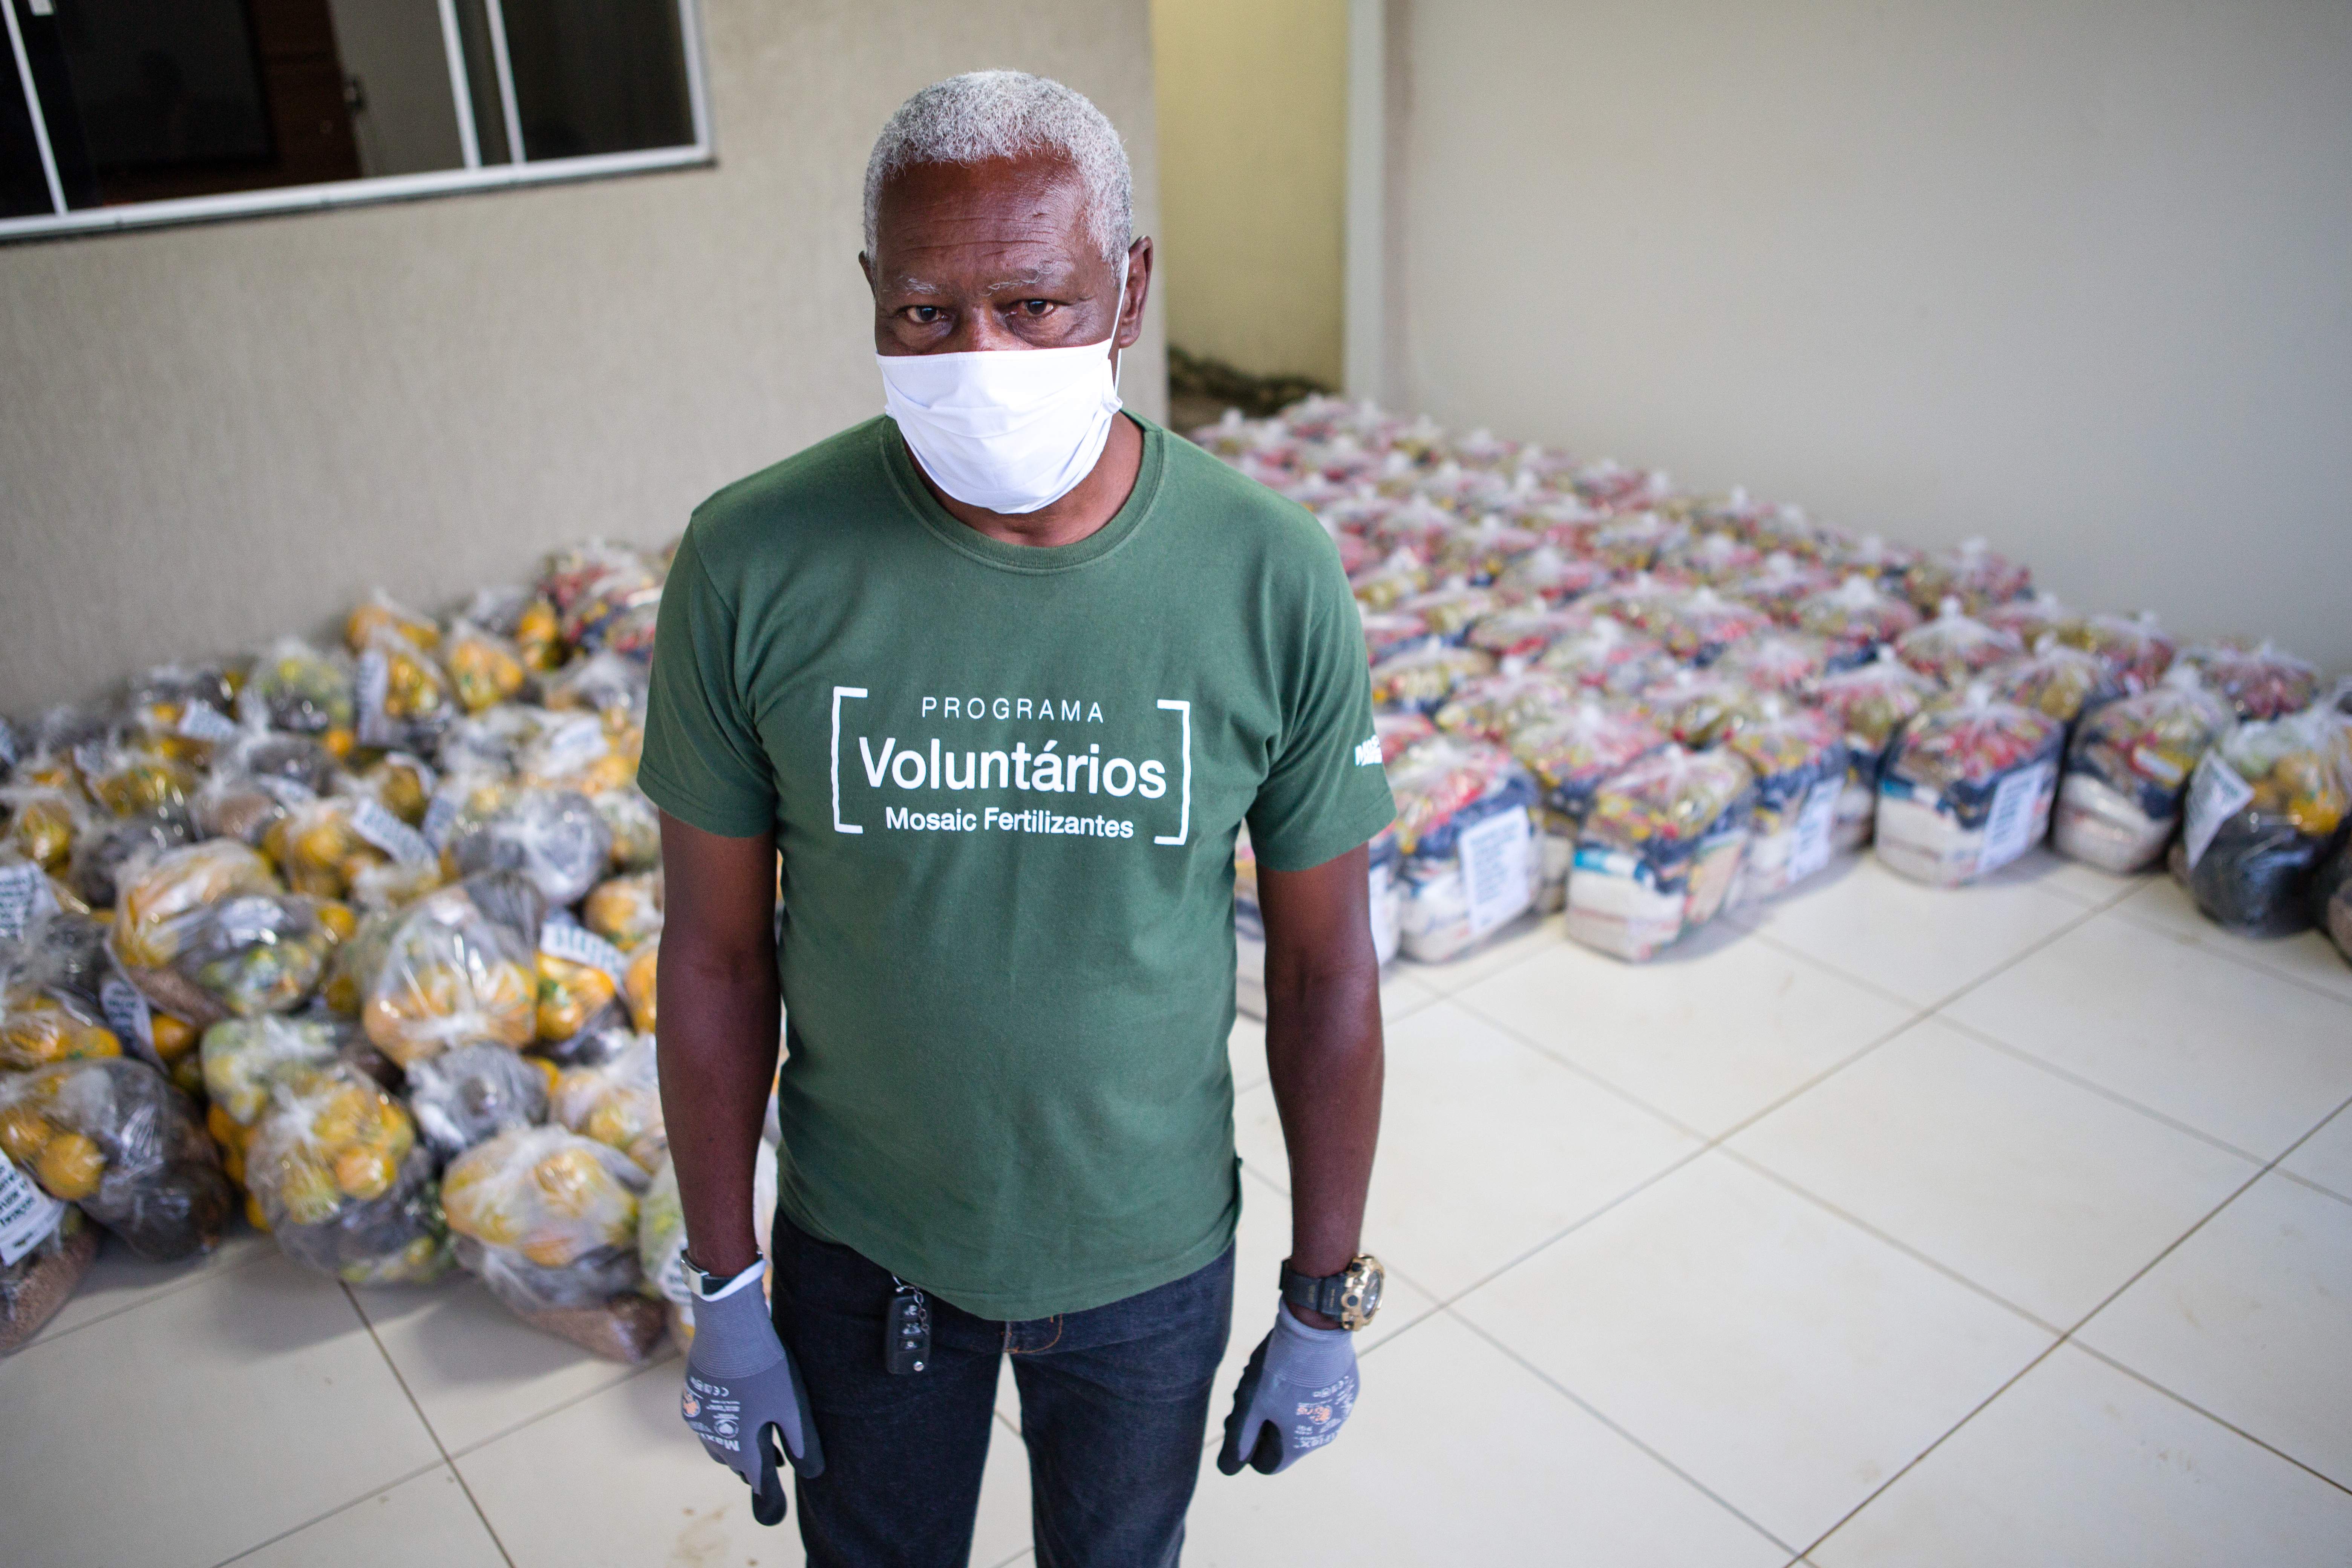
[{"x1": 1249, "y1": 545, "x2": 1397, "y2": 872}]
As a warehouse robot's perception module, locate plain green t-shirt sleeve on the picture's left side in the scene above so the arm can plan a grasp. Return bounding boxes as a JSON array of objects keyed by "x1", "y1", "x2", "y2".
[{"x1": 637, "y1": 527, "x2": 776, "y2": 839}]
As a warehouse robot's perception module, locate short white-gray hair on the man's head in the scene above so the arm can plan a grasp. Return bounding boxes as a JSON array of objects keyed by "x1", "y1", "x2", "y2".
[{"x1": 865, "y1": 70, "x2": 1136, "y2": 266}]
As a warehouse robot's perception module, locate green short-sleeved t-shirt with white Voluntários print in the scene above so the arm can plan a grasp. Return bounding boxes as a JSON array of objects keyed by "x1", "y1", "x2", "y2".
[{"x1": 640, "y1": 418, "x2": 1395, "y2": 1319}]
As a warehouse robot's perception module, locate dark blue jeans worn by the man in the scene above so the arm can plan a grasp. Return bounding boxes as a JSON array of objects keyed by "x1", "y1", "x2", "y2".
[{"x1": 772, "y1": 1215, "x2": 1233, "y2": 1568}]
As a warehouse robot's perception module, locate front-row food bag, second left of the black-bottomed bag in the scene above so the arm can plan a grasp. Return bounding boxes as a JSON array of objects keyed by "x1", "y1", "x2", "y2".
[{"x1": 1877, "y1": 684, "x2": 2065, "y2": 886}]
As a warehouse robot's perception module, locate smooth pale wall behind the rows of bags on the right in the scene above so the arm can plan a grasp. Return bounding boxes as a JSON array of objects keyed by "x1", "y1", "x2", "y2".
[{"x1": 1388, "y1": 0, "x2": 2352, "y2": 668}]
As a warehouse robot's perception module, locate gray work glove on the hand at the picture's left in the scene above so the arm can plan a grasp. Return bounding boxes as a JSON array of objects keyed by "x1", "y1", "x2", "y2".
[{"x1": 677, "y1": 1260, "x2": 825, "y2": 1523}]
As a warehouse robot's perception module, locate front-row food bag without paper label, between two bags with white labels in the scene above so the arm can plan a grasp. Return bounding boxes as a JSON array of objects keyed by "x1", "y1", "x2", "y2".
[{"x1": 1566, "y1": 745, "x2": 1755, "y2": 962}]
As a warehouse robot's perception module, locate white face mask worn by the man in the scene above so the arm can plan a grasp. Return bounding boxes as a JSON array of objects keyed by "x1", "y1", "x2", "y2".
[{"x1": 875, "y1": 259, "x2": 1127, "y2": 513}]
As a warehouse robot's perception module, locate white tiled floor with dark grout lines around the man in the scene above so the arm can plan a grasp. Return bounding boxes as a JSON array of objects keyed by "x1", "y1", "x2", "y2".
[{"x1": 0, "y1": 856, "x2": 2352, "y2": 1568}]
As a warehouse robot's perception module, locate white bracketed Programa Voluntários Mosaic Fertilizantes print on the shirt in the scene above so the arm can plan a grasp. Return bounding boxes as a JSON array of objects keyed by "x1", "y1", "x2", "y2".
[{"x1": 830, "y1": 686, "x2": 1193, "y2": 846}]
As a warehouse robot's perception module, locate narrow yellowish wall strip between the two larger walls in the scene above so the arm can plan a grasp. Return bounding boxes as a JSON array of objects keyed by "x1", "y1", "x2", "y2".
[{"x1": 1153, "y1": 0, "x2": 1348, "y2": 386}]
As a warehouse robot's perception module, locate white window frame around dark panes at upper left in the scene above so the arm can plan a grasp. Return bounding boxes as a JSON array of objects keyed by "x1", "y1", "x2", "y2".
[{"x1": 0, "y1": 0, "x2": 715, "y2": 242}]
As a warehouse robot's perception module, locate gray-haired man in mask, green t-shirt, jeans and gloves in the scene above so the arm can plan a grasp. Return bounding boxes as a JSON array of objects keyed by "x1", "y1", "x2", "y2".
[{"x1": 640, "y1": 70, "x2": 1392, "y2": 1568}]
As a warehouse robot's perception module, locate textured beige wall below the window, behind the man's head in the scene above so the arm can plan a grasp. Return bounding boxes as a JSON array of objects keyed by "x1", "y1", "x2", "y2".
[{"x1": 0, "y1": 0, "x2": 1164, "y2": 715}]
